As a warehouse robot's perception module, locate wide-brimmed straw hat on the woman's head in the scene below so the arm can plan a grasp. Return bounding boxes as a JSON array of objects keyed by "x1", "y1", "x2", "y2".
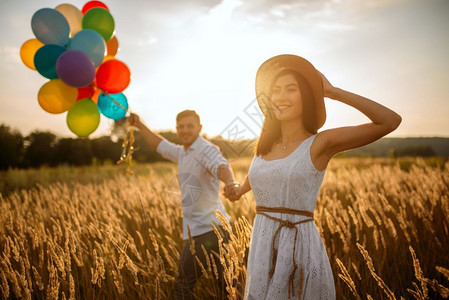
[{"x1": 256, "y1": 54, "x2": 326, "y2": 129}]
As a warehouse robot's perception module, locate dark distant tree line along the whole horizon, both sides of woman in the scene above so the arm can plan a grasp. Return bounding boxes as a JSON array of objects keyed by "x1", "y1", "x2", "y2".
[{"x1": 0, "y1": 124, "x2": 449, "y2": 170}]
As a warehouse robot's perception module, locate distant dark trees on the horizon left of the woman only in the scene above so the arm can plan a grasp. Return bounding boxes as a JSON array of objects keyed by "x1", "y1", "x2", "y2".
[{"x1": 0, "y1": 124, "x2": 253, "y2": 170}]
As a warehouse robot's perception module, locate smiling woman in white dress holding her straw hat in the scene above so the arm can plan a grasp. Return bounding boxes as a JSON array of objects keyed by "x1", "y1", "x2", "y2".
[{"x1": 227, "y1": 55, "x2": 401, "y2": 299}]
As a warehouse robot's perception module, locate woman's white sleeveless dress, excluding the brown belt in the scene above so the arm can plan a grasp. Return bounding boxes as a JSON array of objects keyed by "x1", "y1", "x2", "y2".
[{"x1": 245, "y1": 135, "x2": 335, "y2": 300}]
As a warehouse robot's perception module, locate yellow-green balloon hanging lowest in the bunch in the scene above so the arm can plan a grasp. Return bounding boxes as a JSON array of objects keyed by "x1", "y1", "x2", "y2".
[{"x1": 66, "y1": 98, "x2": 100, "y2": 137}]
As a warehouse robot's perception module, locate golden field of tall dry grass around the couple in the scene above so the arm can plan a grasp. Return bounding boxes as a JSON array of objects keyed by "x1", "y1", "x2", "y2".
[{"x1": 0, "y1": 158, "x2": 449, "y2": 299}]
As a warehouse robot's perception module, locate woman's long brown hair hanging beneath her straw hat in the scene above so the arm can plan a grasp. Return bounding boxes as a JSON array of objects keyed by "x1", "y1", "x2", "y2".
[{"x1": 255, "y1": 69, "x2": 318, "y2": 155}]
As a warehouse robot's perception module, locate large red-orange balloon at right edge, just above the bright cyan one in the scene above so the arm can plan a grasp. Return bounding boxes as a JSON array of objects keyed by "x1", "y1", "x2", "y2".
[{"x1": 95, "y1": 59, "x2": 131, "y2": 94}]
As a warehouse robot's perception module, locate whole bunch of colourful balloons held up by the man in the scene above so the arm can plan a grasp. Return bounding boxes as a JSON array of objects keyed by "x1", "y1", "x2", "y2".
[{"x1": 20, "y1": 1, "x2": 131, "y2": 137}]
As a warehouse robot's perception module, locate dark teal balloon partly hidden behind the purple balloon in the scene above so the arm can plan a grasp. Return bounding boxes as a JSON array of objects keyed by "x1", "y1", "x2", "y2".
[{"x1": 34, "y1": 45, "x2": 66, "y2": 79}]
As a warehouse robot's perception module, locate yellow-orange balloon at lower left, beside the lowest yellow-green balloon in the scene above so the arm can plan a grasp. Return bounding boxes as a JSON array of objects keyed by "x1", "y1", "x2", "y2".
[{"x1": 37, "y1": 79, "x2": 78, "y2": 114}]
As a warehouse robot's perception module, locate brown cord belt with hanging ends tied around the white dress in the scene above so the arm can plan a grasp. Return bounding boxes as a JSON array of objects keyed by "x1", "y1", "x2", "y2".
[{"x1": 256, "y1": 206, "x2": 313, "y2": 299}]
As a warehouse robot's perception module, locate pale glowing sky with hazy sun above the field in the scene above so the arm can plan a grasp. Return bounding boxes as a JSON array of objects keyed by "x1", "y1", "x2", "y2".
[{"x1": 0, "y1": 0, "x2": 449, "y2": 137}]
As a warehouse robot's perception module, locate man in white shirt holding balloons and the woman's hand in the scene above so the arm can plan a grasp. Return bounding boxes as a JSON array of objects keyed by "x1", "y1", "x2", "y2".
[{"x1": 130, "y1": 110, "x2": 234, "y2": 299}]
